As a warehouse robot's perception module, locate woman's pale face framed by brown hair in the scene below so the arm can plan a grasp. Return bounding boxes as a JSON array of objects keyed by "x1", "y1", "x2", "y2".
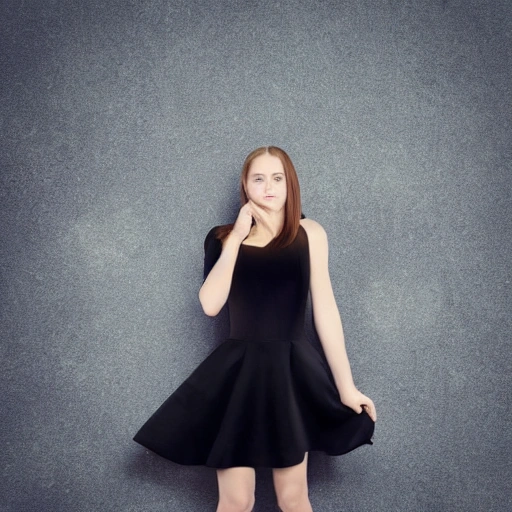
[{"x1": 245, "y1": 153, "x2": 286, "y2": 212}]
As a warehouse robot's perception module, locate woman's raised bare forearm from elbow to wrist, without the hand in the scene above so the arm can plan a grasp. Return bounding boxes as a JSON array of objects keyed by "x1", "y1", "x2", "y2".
[{"x1": 199, "y1": 233, "x2": 242, "y2": 316}]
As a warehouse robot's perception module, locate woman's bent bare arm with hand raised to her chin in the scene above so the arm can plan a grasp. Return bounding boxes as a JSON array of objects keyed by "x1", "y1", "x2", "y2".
[{"x1": 199, "y1": 203, "x2": 252, "y2": 316}]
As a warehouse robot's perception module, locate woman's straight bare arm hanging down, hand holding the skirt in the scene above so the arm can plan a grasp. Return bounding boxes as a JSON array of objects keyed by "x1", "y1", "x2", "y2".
[{"x1": 301, "y1": 219, "x2": 377, "y2": 421}]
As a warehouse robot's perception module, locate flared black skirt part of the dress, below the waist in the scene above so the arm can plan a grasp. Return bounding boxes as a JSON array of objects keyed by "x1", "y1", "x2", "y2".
[{"x1": 134, "y1": 339, "x2": 375, "y2": 468}]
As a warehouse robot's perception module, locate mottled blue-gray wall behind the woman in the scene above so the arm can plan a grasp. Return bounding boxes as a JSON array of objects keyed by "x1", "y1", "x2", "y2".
[{"x1": 0, "y1": 0, "x2": 512, "y2": 512}]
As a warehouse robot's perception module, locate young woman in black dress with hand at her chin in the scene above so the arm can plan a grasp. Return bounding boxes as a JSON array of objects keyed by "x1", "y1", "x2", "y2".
[{"x1": 134, "y1": 146, "x2": 376, "y2": 512}]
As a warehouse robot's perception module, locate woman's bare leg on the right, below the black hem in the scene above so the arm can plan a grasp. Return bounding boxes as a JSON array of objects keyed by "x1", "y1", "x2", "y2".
[{"x1": 273, "y1": 453, "x2": 313, "y2": 512}]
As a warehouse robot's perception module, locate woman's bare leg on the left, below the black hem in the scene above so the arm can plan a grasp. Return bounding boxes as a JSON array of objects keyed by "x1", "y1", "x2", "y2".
[{"x1": 217, "y1": 468, "x2": 256, "y2": 512}]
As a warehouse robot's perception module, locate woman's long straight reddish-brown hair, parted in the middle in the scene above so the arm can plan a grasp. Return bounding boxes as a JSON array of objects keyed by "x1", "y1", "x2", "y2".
[{"x1": 216, "y1": 146, "x2": 302, "y2": 249}]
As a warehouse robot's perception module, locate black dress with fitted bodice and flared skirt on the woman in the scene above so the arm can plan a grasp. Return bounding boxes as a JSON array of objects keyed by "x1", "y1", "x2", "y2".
[{"x1": 134, "y1": 226, "x2": 374, "y2": 468}]
